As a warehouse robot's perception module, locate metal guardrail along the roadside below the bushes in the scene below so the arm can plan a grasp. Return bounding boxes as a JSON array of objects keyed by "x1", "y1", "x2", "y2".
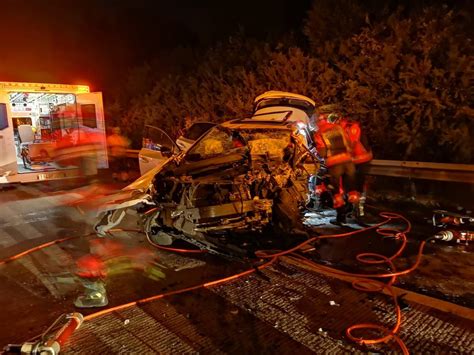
[{"x1": 127, "y1": 149, "x2": 474, "y2": 184}]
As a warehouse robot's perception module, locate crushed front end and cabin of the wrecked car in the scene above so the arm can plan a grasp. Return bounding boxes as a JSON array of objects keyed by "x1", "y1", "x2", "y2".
[{"x1": 95, "y1": 111, "x2": 318, "y2": 254}]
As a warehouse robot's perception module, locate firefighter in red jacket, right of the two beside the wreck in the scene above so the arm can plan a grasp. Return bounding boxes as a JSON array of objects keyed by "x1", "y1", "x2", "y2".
[{"x1": 340, "y1": 118, "x2": 373, "y2": 222}]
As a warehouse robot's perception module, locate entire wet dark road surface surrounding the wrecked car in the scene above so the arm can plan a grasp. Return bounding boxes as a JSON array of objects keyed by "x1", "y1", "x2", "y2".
[{"x1": 0, "y1": 178, "x2": 474, "y2": 353}]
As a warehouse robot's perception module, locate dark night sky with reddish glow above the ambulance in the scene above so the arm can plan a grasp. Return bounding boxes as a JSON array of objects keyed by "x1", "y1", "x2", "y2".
[{"x1": 0, "y1": 0, "x2": 310, "y2": 90}]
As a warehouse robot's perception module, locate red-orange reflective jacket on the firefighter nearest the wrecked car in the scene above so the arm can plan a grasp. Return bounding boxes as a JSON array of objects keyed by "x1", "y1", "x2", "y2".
[{"x1": 314, "y1": 120, "x2": 352, "y2": 167}]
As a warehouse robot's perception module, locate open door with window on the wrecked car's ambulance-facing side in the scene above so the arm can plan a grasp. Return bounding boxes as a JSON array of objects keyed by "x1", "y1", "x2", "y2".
[{"x1": 138, "y1": 125, "x2": 181, "y2": 175}]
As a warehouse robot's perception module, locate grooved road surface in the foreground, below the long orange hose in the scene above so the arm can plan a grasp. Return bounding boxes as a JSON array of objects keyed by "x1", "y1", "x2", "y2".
[{"x1": 64, "y1": 261, "x2": 474, "y2": 354}]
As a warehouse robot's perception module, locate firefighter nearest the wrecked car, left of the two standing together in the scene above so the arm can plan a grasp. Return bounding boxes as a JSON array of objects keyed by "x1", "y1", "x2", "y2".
[{"x1": 314, "y1": 110, "x2": 359, "y2": 224}]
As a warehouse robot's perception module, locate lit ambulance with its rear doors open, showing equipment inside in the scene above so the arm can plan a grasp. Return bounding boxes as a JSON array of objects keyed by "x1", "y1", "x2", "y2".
[{"x1": 0, "y1": 81, "x2": 108, "y2": 183}]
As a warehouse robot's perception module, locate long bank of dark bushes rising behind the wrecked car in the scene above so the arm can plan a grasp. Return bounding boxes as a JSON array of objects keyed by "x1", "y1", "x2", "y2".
[{"x1": 112, "y1": 0, "x2": 474, "y2": 163}]
